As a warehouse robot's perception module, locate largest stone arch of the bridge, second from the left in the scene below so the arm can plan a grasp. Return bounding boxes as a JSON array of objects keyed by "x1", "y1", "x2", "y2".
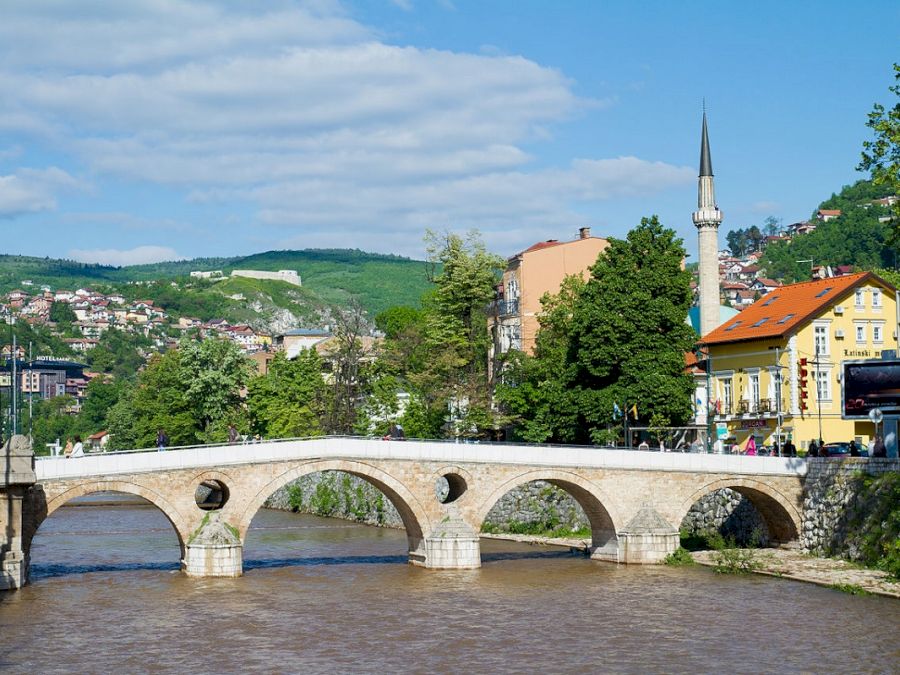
[{"x1": 237, "y1": 460, "x2": 431, "y2": 555}]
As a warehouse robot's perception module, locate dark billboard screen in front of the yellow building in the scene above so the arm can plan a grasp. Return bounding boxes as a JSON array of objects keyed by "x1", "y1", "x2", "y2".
[{"x1": 841, "y1": 360, "x2": 900, "y2": 418}]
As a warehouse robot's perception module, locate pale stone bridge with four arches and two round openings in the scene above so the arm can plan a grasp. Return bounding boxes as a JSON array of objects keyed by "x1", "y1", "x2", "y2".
[{"x1": 0, "y1": 437, "x2": 806, "y2": 587}]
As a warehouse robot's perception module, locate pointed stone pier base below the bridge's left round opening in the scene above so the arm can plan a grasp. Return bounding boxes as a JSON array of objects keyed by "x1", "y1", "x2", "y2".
[{"x1": 181, "y1": 511, "x2": 244, "y2": 577}]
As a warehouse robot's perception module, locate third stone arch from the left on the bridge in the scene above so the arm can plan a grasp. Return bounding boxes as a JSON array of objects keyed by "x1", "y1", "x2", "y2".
[{"x1": 475, "y1": 469, "x2": 622, "y2": 559}]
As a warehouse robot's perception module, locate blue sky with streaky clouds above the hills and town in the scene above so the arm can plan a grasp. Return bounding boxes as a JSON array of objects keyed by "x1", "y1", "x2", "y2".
[{"x1": 0, "y1": 0, "x2": 900, "y2": 265}]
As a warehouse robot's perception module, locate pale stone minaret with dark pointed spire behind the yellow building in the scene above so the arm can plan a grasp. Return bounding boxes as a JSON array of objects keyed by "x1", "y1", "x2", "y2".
[{"x1": 693, "y1": 110, "x2": 722, "y2": 337}]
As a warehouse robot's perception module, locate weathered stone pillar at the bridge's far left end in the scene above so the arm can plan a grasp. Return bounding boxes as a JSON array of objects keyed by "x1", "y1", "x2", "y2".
[{"x1": 0, "y1": 436, "x2": 37, "y2": 590}]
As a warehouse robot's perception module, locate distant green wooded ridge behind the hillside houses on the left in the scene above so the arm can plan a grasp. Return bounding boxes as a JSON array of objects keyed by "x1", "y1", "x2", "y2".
[{"x1": 0, "y1": 249, "x2": 428, "y2": 325}]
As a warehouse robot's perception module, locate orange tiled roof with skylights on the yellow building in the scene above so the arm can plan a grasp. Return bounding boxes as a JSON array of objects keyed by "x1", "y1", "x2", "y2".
[{"x1": 700, "y1": 272, "x2": 896, "y2": 344}]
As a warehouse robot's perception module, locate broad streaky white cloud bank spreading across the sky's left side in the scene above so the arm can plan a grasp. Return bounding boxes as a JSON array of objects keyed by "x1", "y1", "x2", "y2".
[{"x1": 0, "y1": 0, "x2": 695, "y2": 257}]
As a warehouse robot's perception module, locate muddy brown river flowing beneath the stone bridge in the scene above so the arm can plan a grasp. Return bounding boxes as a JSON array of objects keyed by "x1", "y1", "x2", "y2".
[{"x1": 0, "y1": 499, "x2": 900, "y2": 673}]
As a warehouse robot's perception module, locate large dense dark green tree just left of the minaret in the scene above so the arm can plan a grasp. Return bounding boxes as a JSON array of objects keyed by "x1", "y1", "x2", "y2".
[{"x1": 567, "y1": 216, "x2": 694, "y2": 440}]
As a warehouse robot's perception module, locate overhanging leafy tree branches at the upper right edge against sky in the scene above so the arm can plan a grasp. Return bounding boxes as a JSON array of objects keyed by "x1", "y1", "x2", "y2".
[{"x1": 856, "y1": 63, "x2": 900, "y2": 242}]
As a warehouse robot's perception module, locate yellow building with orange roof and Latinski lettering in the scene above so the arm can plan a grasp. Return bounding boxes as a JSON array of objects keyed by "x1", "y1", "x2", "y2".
[{"x1": 700, "y1": 272, "x2": 898, "y2": 450}]
